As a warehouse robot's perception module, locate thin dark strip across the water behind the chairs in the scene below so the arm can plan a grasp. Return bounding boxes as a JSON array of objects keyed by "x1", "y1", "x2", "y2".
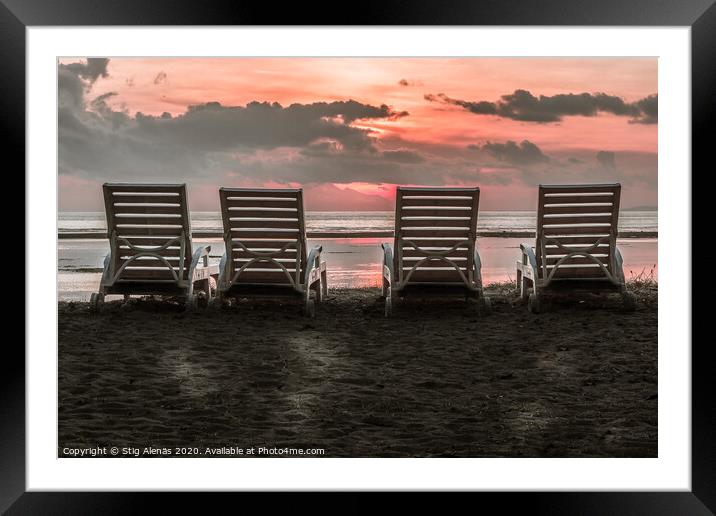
[{"x1": 57, "y1": 231, "x2": 659, "y2": 240}]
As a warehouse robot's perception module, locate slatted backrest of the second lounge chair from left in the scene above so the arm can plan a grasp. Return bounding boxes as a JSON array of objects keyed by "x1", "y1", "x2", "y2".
[{"x1": 219, "y1": 188, "x2": 306, "y2": 285}]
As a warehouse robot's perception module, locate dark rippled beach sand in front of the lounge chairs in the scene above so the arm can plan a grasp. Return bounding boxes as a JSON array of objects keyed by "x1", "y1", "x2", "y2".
[{"x1": 58, "y1": 289, "x2": 657, "y2": 457}]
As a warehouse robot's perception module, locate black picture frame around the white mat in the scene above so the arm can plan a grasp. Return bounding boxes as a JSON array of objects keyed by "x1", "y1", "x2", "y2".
[{"x1": 0, "y1": 0, "x2": 716, "y2": 514}]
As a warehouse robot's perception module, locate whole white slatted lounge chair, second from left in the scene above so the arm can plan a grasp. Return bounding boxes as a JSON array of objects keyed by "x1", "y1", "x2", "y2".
[{"x1": 214, "y1": 188, "x2": 328, "y2": 317}]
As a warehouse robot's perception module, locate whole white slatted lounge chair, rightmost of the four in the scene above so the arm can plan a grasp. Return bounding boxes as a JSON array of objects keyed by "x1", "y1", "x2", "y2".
[{"x1": 517, "y1": 184, "x2": 635, "y2": 313}]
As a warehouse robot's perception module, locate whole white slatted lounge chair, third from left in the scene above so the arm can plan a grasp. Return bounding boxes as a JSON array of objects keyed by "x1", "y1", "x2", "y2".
[{"x1": 382, "y1": 187, "x2": 490, "y2": 317}]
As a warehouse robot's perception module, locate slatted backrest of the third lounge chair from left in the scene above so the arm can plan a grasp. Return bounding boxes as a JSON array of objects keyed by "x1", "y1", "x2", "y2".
[{"x1": 394, "y1": 187, "x2": 480, "y2": 284}]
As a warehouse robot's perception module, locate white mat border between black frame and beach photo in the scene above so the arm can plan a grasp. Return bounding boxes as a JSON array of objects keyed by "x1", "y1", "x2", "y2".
[{"x1": 26, "y1": 27, "x2": 691, "y2": 491}]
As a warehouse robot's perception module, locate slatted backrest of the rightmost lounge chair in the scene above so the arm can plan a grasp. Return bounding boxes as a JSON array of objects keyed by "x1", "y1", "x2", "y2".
[{"x1": 535, "y1": 183, "x2": 621, "y2": 279}]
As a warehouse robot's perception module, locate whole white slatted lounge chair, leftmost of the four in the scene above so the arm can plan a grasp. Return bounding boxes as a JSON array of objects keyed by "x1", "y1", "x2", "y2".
[{"x1": 90, "y1": 183, "x2": 219, "y2": 310}]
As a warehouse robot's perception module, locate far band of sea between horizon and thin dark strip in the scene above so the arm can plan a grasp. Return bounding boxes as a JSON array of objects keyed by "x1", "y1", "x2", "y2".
[{"x1": 58, "y1": 211, "x2": 658, "y2": 233}]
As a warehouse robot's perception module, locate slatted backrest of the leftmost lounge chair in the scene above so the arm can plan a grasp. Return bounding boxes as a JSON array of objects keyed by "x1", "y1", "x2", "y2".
[{"x1": 102, "y1": 183, "x2": 192, "y2": 281}]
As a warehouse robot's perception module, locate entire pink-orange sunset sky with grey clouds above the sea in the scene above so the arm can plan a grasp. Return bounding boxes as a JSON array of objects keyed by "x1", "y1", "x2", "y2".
[{"x1": 58, "y1": 58, "x2": 658, "y2": 211}]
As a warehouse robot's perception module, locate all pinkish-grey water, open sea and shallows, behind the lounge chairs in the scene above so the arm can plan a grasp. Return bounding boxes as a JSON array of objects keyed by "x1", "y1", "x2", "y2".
[{"x1": 57, "y1": 212, "x2": 658, "y2": 301}]
